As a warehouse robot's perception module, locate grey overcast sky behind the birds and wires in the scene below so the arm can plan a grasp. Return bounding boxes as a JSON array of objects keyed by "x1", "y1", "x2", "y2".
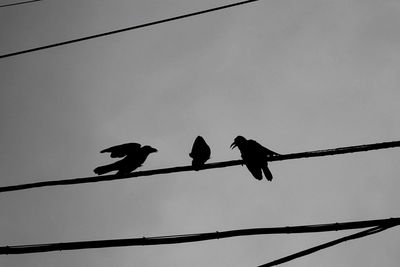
[{"x1": 0, "y1": 0, "x2": 400, "y2": 267}]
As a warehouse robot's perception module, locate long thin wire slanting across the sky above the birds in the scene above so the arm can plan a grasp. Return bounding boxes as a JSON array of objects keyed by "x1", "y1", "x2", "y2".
[{"x1": 0, "y1": 0, "x2": 260, "y2": 58}]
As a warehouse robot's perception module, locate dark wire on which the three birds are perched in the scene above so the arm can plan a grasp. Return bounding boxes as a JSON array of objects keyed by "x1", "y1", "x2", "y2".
[{"x1": 0, "y1": 141, "x2": 400, "y2": 193}]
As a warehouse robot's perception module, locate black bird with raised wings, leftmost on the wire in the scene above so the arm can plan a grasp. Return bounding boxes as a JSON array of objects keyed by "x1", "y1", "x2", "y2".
[{"x1": 93, "y1": 143, "x2": 158, "y2": 175}]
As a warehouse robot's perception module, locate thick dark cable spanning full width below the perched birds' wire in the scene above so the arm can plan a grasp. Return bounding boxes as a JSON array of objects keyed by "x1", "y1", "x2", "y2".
[{"x1": 0, "y1": 217, "x2": 400, "y2": 255}]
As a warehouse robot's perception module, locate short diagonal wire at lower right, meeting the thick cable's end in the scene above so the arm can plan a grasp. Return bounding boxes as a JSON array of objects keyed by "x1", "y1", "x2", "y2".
[{"x1": 258, "y1": 225, "x2": 396, "y2": 267}]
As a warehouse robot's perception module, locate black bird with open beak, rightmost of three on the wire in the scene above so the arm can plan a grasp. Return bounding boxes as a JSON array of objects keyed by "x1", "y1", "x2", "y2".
[{"x1": 231, "y1": 135, "x2": 279, "y2": 181}]
